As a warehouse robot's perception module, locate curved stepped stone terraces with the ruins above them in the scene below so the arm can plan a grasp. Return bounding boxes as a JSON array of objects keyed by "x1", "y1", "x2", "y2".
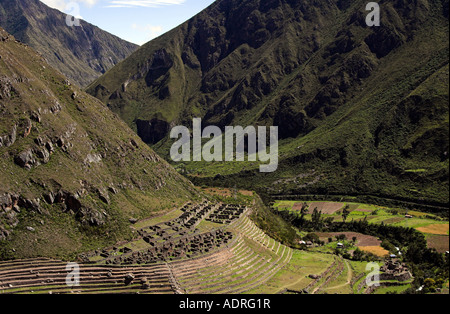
[{"x1": 0, "y1": 202, "x2": 293, "y2": 294}]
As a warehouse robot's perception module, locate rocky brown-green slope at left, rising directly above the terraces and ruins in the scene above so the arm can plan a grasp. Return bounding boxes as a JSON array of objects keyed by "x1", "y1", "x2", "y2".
[{"x1": 0, "y1": 29, "x2": 198, "y2": 259}]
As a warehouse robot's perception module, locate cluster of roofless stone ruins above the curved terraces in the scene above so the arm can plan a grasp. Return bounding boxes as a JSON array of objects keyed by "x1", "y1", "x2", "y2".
[{"x1": 80, "y1": 201, "x2": 237, "y2": 265}]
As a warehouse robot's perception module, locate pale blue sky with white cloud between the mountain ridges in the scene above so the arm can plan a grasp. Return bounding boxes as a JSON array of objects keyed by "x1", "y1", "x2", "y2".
[{"x1": 41, "y1": 0, "x2": 214, "y2": 45}]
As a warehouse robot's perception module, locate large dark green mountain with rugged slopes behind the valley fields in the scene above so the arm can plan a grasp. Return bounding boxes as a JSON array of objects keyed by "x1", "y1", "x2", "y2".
[{"x1": 87, "y1": 0, "x2": 449, "y2": 211}]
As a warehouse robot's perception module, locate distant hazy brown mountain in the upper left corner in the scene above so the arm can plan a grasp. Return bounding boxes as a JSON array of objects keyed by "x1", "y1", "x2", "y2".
[{"x1": 0, "y1": 0, "x2": 138, "y2": 87}]
